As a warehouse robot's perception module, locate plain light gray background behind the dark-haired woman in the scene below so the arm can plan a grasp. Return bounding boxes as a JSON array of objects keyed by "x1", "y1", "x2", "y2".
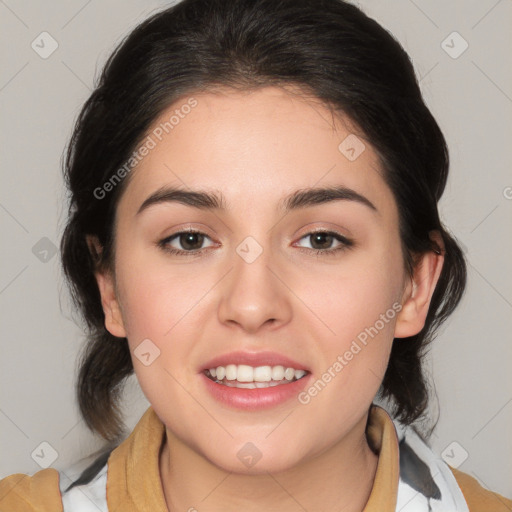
[{"x1": 0, "y1": 0, "x2": 512, "y2": 497}]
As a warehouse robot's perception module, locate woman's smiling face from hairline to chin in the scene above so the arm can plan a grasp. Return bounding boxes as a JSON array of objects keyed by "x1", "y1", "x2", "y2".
[{"x1": 95, "y1": 87, "x2": 420, "y2": 473}]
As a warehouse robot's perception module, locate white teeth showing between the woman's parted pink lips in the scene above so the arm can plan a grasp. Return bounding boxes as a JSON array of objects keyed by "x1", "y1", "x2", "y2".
[{"x1": 203, "y1": 364, "x2": 310, "y2": 389}]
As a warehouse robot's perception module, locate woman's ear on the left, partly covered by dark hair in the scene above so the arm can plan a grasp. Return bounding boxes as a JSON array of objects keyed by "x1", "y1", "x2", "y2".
[{"x1": 86, "y1": 235, "x2": 126, "y2": 338}]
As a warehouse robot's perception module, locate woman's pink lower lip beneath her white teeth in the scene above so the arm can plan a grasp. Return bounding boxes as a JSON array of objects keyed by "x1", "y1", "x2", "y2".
[{"x1": 200, "y1": 373, "x2": 311, "y2": 411}]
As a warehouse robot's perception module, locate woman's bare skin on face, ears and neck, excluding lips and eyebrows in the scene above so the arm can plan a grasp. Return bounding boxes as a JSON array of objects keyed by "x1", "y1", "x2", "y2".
[{"x1": 91, "y1": 87, "x2": 443, "y2": 511}]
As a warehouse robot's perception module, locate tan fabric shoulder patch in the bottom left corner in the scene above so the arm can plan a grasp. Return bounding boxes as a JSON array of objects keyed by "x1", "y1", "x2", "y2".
[{"x1": 0, "y1": 468, "x2": 62, "y2": 512}]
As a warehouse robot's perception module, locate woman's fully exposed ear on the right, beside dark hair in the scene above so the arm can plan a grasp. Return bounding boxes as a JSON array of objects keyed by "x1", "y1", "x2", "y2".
[{"x1": 395, "y1": 231, "x2": 444, "y2": 338}]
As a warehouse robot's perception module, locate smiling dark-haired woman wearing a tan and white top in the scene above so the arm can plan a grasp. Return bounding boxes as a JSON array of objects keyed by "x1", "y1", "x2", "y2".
[{"x1": 0, "y1": 0, "x2": 512, "y2": 512}]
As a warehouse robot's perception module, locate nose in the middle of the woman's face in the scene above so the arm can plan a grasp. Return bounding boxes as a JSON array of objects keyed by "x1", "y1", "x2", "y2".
[{"x1": 218, "y1": 242, "x2": 293, "y2": 334}]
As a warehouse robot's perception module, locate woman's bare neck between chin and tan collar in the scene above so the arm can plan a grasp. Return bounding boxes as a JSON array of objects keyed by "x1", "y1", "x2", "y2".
[{"x1": 160, "y1": 416, "x2": 378, "y2": 512}]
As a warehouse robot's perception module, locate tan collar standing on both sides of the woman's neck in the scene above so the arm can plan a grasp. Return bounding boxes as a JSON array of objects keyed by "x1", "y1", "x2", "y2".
[{"x1": 107, "y1": 406, "x2": 399, "y2": 512}]
